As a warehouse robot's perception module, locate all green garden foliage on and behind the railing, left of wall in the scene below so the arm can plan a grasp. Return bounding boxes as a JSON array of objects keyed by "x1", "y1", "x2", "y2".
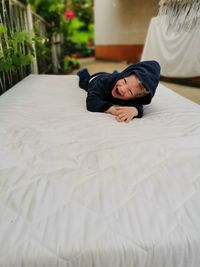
[{"x1": 0, "y1": 0, "x2": 94, "y2": 79}]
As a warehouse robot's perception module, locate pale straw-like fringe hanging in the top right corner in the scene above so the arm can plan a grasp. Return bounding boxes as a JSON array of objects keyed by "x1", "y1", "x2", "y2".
[{"x1": 158, "y1": 0, "x2": 200, "y2": 31}]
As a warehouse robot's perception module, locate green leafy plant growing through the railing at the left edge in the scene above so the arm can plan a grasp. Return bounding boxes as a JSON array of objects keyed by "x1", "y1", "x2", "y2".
[{"x1": 0, "y1": 24, "x2": 35, "y2": 72}]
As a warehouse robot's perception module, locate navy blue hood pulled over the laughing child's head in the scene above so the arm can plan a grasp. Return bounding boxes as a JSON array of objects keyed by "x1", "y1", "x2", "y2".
[{"x1": 117, "y1": 60, "x2": 160, "y2": 104}]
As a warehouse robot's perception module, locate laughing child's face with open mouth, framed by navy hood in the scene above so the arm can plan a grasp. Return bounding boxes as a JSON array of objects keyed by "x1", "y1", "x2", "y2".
[{"x1": 111, "y1": 75, "x2": 144, "y2": 100}]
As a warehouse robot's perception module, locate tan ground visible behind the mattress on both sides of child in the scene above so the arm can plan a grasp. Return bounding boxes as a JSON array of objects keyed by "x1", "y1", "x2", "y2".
[{"x1": 74, "y1": 58, "x2": 200, "y2": 104}]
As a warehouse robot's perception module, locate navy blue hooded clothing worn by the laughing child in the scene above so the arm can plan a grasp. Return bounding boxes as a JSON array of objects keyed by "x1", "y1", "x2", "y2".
[{"x1": 77, "y1": 60, "x2": 160, "y2": 118}]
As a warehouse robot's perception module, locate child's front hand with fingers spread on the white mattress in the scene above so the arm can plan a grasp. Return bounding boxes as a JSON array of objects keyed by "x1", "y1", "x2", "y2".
[{"x1": 115, "y1": 107, "x2": 138, "y2": 123}]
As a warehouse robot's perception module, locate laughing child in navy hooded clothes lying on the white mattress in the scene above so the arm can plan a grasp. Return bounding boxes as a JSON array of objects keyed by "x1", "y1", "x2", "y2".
[{"x1": 77, "y1": 60, "x2": 160, "y2": 123}]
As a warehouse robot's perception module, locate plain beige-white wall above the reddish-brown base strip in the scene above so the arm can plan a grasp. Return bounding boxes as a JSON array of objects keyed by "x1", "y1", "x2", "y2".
[{"x1": 94, "y1": 0, "x2": 159, "y2": 45}]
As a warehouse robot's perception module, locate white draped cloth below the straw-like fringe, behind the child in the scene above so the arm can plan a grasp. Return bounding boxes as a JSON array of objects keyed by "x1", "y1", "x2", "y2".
[{"x1": 142, "y1": 16, "x2": 200, "y2": 78}]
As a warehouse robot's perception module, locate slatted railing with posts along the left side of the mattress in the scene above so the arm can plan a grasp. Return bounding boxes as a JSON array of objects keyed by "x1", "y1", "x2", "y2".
[{"x1": 0, "y1": 0, "x2": 62, "y2": 94}]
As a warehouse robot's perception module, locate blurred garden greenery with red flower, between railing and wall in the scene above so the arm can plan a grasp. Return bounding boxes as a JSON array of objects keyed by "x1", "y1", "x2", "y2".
[{"x1": 29, "y1": 0, "x2": 94, "y2": 72}]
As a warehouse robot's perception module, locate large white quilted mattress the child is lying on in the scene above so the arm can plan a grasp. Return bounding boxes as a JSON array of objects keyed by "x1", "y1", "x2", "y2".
[{"x1": 0, "y1": 75, "x2": 200, "y2": 267}]
